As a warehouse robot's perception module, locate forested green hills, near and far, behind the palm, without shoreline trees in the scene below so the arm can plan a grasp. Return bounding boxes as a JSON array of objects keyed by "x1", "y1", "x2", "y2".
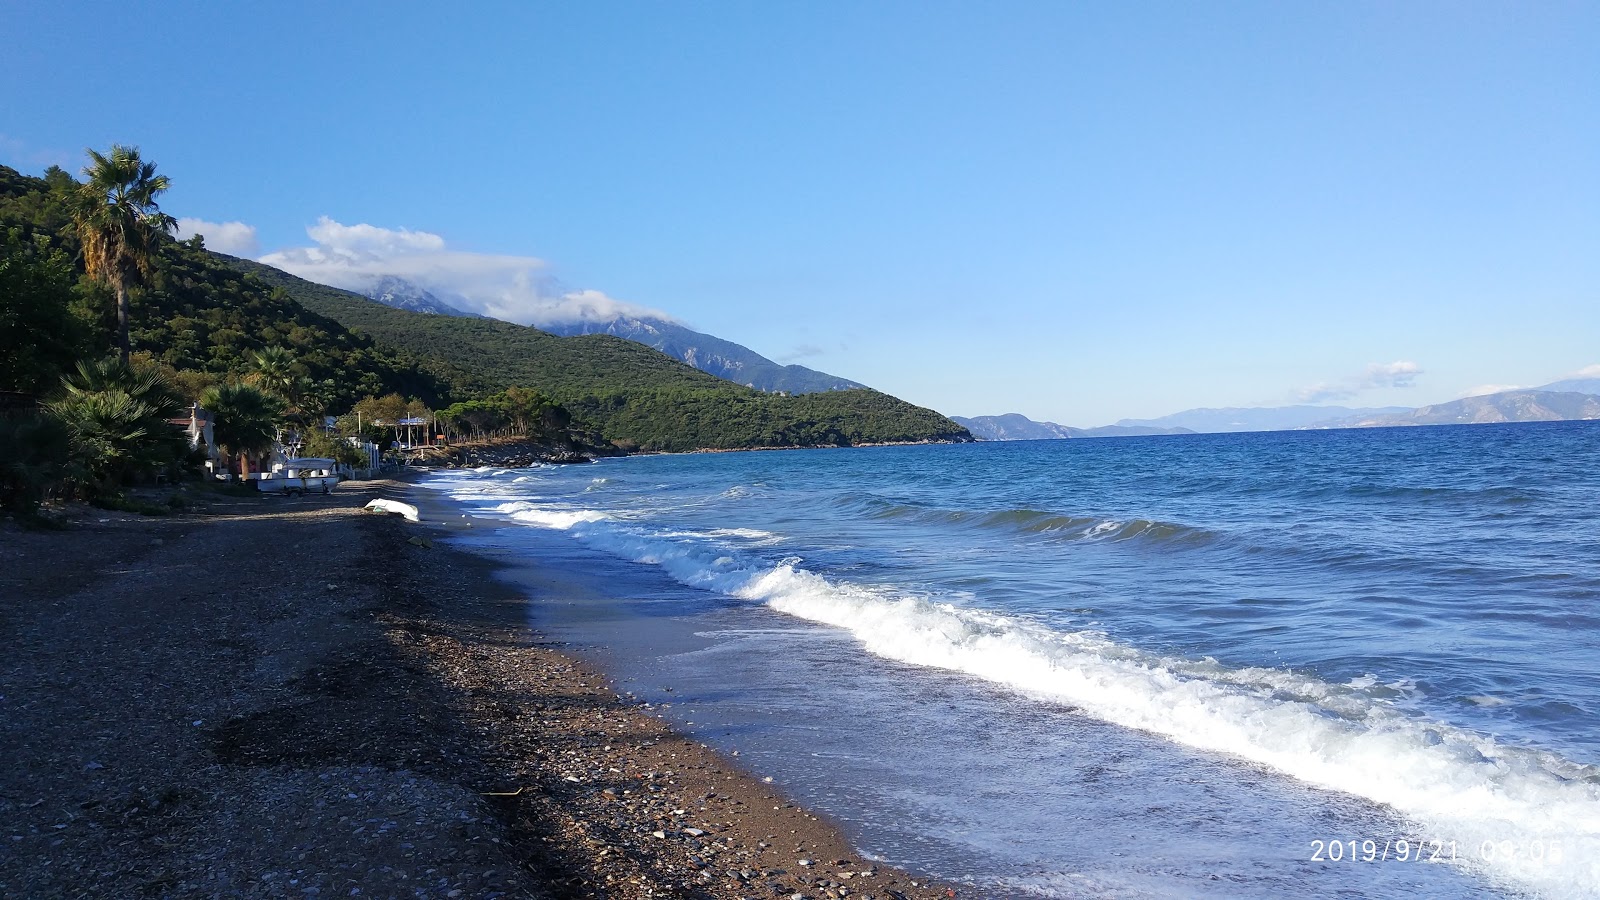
[{"x1": 0, "y1": 158, "x2": 968, "y2": 450}]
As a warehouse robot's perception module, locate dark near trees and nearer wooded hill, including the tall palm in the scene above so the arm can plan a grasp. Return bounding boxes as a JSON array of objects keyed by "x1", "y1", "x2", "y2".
[{"x1": 0, "y1": 144, "x2": 588, "y2": 511}]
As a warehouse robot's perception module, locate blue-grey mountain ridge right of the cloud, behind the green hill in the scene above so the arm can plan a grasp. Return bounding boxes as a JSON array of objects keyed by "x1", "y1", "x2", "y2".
[{"x1": 541, "y1": 317, "x2": 866, "y2": 394}]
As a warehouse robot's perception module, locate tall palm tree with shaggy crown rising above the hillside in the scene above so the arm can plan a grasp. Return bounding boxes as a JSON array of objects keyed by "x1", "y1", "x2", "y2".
[{"x1": 72, "y1": 144, "x2": 178, "y2": 362}]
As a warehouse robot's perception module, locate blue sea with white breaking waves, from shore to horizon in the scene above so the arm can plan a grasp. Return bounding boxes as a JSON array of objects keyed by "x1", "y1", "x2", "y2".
[{"x1": 424, "y1": 423, "x2": 1600, "y2": 898}]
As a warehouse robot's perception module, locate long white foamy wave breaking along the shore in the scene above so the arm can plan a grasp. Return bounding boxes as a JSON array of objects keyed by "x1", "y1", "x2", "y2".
[{"x1": 448, "y1": 486, "x2": 1600, "y2": 897}]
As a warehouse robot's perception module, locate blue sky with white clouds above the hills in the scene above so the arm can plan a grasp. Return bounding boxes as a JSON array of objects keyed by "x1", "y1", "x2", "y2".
[{"x1": 0, "y1": 0, "x2": 1600, "y2": 426}]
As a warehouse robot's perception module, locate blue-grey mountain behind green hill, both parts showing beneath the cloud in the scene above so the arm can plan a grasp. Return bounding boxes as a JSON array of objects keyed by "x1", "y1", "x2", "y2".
[{"x1": 362, "y1": 275, "x2": 866, "y2": 394}]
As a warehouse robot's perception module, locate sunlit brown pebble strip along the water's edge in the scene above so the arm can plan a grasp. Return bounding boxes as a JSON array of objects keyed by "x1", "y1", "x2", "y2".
[{"x1": 405, "y1": 469, "x2": 973, "y2": 898}]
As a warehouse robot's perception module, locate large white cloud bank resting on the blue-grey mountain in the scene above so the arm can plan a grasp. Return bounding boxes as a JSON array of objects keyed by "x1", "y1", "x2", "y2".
[{"x1": 261, "y1": 216, "x2": 672, "y2": 325}]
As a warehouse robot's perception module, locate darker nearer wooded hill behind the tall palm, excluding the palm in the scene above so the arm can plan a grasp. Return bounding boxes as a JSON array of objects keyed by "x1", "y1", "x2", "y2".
[{"x1": 0, "y1": 165, "x2": 464, "y2": 412}]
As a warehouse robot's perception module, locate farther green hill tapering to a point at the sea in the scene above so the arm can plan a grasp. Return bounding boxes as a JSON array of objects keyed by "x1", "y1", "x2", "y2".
[{"x1": 222, "y1": 256, "x2": 968, "y2": 450}]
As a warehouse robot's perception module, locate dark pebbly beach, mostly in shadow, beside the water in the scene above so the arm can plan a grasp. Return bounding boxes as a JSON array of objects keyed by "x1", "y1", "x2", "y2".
[{"x1": 0, "y1": 482, "x2": 954, "y2": 898}]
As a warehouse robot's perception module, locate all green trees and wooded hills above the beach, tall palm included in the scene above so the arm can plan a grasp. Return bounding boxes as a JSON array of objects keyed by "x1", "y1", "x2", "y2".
[{"x1": 0, "y1": 146, "x2": 966, "y2": 509}]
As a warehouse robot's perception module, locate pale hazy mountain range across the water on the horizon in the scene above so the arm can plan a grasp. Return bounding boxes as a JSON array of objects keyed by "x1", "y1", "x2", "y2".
[{"x1": 950, "y1": 378, "x2": 1600, "y2": 440}]
